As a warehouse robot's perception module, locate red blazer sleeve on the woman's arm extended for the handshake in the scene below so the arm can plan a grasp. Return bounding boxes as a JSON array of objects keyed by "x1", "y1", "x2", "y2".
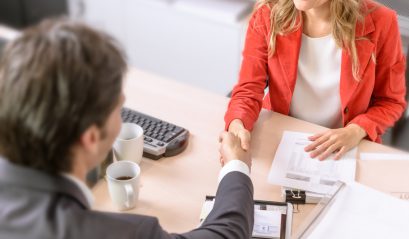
[{"x1": 224, "y1": 6, "x2": 270, "y2": 130}]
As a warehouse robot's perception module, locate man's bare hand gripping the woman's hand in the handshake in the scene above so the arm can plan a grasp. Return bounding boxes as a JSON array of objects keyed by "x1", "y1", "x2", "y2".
[{"x1": 219, "y1": 132, "x2": 251, "y2": 168}]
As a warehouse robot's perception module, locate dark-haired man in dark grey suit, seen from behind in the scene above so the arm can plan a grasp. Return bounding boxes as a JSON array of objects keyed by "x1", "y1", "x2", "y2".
[{"x1": 0, "y1": 21, "x2": 253, "y2": 239}]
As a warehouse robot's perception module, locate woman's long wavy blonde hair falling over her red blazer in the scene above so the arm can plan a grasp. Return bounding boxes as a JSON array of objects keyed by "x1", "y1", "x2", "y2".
[{"x1": 256, "y1": 0, "x2": 364, "y2": 80}]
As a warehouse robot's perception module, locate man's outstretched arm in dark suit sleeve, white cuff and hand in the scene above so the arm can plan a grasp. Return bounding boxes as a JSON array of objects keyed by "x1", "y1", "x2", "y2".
[{"x1": 130, "y1": 132, "x2": 254, "y2": 239}]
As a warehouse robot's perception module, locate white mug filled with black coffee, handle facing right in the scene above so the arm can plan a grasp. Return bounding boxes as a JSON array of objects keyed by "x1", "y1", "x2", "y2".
[{"x1": 106, "y1": 161, "x2": 141, "y2": 210}]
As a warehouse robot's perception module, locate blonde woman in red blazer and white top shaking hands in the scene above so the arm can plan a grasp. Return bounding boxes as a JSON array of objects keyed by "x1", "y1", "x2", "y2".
[{"x1": 225, "y1": 0, "x2": 406, "y2": 160}]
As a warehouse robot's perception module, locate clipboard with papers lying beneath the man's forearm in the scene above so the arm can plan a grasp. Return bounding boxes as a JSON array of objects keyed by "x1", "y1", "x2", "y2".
[{"x1": 200, "y1": 196, "x2": 293, "y2": 239}]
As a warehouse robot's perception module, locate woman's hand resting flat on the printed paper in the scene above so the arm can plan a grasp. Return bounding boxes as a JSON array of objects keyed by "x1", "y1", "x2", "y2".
[{"x1": 305, "y1": 124, "x2": 366, "y2": 160}]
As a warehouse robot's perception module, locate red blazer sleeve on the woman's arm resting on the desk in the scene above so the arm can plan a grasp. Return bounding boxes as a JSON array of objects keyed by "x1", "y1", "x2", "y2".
[{"x1": 350, "y1": 13, "x2": 406, "y2": 142}]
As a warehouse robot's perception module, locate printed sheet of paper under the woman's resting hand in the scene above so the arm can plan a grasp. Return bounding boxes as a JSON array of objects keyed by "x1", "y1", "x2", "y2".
[{"x1": 268, "y1": 131, "x2": 357, "y2": 193}]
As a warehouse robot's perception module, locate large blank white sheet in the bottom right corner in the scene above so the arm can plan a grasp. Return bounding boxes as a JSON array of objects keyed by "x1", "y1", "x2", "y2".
[{"x1": 308, "y1": 182, "x2": 409, "y2": 239}]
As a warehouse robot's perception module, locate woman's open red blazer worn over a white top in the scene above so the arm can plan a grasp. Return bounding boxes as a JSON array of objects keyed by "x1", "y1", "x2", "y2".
[{"x1": 225, "y1": 1, "x2": 406, "y2": 142}]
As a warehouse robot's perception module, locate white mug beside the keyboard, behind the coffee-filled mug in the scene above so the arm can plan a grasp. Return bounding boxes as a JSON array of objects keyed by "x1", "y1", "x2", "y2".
[{"x1": 114, "y1": 123, "x2": 143, "y2": 163}]
